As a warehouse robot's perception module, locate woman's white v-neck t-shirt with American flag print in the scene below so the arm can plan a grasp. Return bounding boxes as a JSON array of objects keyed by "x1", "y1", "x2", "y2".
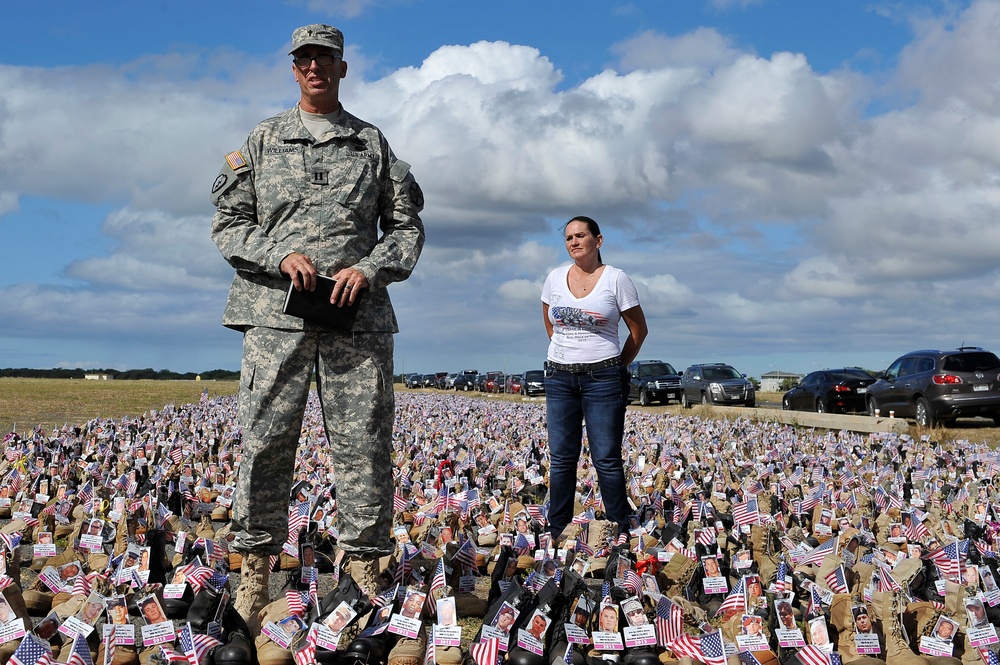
[{"x1": 542, "y1": 265, "x2": 639, "y2": 364}]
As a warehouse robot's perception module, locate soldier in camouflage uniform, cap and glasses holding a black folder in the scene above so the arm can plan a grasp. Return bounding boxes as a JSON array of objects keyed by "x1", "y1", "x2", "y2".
[{"x1": 212, "y1": 25, "x2": 424, "y2": 618}]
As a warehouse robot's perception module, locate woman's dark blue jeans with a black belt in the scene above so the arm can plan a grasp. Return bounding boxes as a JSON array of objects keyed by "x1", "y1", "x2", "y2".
[{"x1": 545, "y1": 366, "x2": 629, "y2": 537}]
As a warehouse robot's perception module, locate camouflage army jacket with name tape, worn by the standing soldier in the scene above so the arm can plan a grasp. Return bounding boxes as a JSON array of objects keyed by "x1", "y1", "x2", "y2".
[{"x1": 212, "y1": 107, "x2": 424, "y2": 332}]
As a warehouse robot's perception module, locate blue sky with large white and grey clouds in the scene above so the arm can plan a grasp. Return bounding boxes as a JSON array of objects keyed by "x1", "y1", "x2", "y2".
[{"x1": 0, "y1": 0, "x2": 1000, "y2": 376}]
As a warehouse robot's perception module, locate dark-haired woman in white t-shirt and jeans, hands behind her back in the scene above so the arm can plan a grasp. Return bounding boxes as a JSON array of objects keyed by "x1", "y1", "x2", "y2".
[{"x1": 542, "y1": 217, "x2": 647, "y2": 538}]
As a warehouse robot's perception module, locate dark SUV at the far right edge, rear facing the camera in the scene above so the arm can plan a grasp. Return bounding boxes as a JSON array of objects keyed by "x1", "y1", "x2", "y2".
[{"x1": 867, "y1": 346, "x2": 1000, "y2": 427}]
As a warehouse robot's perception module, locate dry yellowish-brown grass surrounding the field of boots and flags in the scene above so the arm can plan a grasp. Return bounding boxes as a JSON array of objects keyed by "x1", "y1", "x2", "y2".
[{"x1": 0, "y1": 378, "x2": 1000, "y2": 447}]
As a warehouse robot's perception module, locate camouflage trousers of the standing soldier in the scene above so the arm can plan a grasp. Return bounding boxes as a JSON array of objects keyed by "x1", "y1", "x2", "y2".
[{"x1": 232, "y1": 328, "x2": 395, "y2": 555}]
